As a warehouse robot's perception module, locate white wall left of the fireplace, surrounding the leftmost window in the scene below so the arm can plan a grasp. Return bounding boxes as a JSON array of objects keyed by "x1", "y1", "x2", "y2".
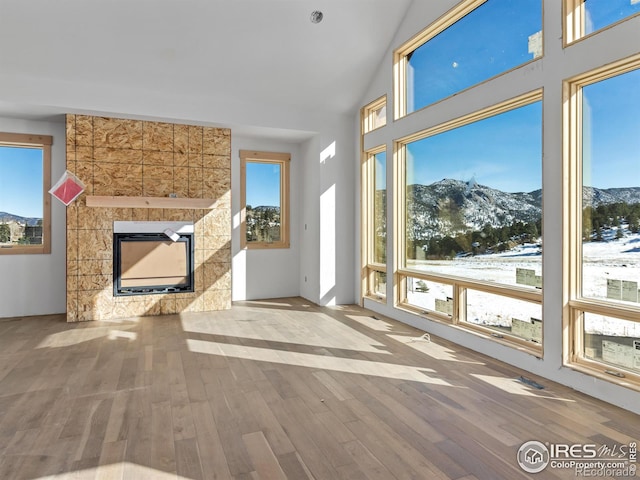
[{"x1": 0, "y1": 118, "x2": 67, "y2": 318}]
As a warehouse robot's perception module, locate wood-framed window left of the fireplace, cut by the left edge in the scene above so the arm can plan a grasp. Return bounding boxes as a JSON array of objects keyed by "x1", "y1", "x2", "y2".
[{"x1": 0, "y1": 133, "x2": 52, "y2": 255}]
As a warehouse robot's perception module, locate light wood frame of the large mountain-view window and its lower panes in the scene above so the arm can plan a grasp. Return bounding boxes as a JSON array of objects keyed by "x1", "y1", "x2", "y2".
[{"x1": 393, "y1": 88, "x2": 544, "y2": 357}]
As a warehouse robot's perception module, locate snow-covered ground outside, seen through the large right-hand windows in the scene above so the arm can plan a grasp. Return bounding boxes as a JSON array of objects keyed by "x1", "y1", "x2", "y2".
[{"x1": 408, "y1": 229, "x2": 640, "y2": 338}]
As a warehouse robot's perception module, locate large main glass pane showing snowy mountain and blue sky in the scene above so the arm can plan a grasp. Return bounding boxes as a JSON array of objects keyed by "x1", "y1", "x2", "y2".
[{"x1": 402, "y1": 94, "x2": 542, "y2": 288}]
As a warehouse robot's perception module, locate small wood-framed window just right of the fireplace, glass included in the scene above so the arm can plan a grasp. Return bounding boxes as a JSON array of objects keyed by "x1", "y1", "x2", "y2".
[{"x1": 240, "y1": 150, "x2": 291, "y2": 248}]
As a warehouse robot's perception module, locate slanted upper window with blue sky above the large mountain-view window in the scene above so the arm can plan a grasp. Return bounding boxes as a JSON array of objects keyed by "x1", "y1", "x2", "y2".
[{"x1": 395, "y1": 0, "x2": 542, "y2": 118}]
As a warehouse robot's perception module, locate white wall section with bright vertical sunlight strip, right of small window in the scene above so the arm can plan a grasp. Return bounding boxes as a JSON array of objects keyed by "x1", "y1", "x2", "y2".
[{"x1": 292, "y1": 123, "x2": 358, "y2": 305}]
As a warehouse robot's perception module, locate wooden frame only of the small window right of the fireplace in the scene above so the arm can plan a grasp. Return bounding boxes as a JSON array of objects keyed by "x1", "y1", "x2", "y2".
[{"x1": 240, "y1": 150, "x2": 291, "y2": 250}]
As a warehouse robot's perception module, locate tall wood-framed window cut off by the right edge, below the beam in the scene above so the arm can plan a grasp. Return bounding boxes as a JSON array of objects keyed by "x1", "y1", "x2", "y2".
[{"x1": 566, "y1": 56, "x2": 640, "y2": 381}]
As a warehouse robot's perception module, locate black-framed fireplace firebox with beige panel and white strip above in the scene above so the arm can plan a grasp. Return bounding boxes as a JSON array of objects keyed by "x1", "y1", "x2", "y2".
[{"x1": 113, "y1": 222, "x2": 195, "y2": 296}]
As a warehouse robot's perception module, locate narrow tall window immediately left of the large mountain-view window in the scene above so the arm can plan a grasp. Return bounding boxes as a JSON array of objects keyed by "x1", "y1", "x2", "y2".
[{"x1": 363, "y1": 146, "x2": 387, "y2": 298}]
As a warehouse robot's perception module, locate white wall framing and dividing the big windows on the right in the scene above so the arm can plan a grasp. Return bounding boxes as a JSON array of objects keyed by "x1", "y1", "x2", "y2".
[{"x1": 354, "y1": 0, "x2": 640, "y2": 413}]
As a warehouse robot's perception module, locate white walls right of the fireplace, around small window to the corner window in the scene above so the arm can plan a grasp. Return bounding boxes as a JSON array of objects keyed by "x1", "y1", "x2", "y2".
[{"x1": 232, "y1": 117, "x2": 357, "y2": 305}]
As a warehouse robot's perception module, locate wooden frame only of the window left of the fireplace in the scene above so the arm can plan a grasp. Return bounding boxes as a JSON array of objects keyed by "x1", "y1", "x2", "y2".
[{"x1": 0, "y1": 132, "x2": 53, "y2": 255}]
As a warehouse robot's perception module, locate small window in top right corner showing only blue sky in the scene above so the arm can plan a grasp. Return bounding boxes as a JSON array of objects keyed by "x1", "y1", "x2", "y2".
[{"x1": 566, "y1": 0, "x2": 640, "y2": 43}]
